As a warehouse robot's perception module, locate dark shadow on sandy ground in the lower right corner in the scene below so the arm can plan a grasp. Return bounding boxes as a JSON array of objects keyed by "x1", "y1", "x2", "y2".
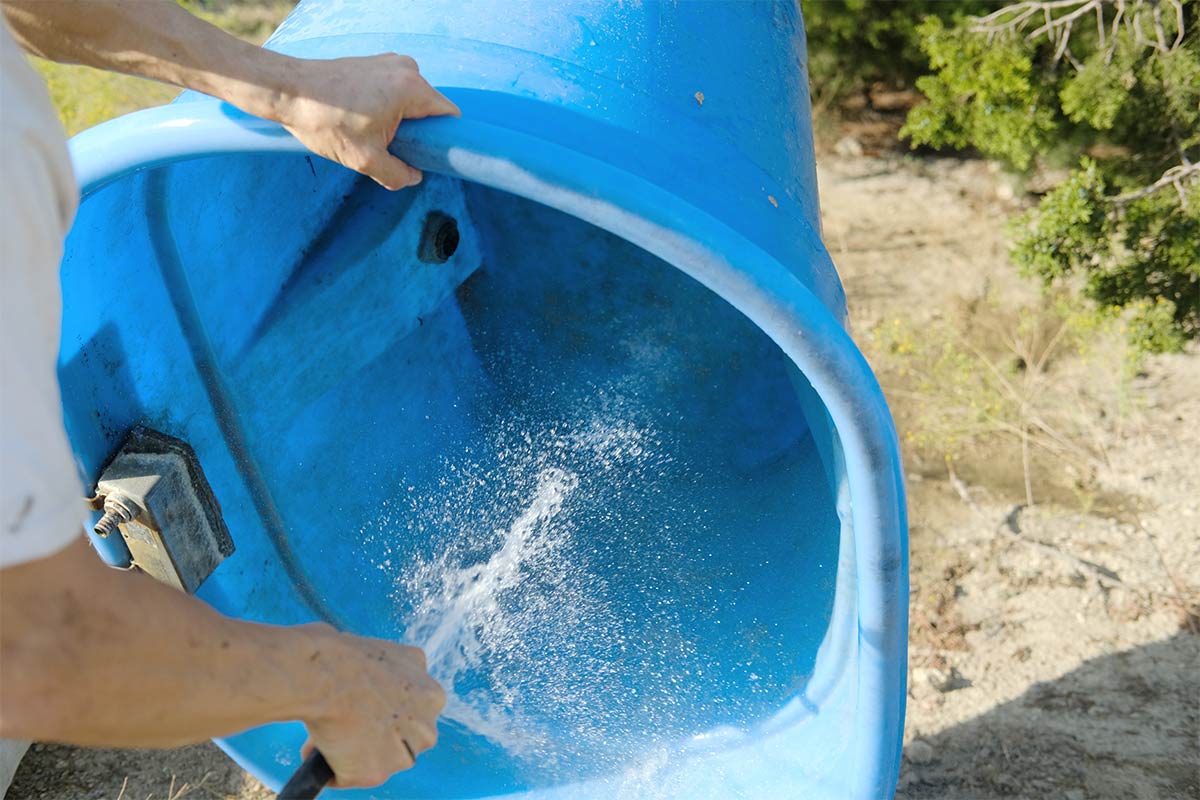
[{"x1": 896, "y1": 632, "x2": 1200, "y2": 800}]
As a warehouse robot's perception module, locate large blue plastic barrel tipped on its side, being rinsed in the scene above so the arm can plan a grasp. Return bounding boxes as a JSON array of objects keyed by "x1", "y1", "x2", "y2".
[{"x1": 60, "y1": 0, "x2": 907, "y2": 800}]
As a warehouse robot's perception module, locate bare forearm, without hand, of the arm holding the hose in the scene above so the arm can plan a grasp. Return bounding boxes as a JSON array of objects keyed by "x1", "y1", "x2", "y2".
[{"x1": 0, "y1": 539, "x2": 328, "y2": 747}]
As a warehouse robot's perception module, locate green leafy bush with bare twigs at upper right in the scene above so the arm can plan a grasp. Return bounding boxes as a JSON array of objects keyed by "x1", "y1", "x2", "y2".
[{"x1": 901, "y1": 0, "x2": 1200, "y2": 351}]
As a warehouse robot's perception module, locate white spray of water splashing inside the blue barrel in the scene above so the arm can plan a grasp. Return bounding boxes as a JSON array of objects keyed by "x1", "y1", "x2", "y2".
[{"x1": 371, "y1": 410, "x2": 696, "y2": 778}]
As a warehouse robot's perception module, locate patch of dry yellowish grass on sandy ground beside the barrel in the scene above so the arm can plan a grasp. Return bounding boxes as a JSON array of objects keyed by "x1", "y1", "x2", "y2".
[{"x1": 865, "y1": 291, "x2": 1138, "y2": 516}]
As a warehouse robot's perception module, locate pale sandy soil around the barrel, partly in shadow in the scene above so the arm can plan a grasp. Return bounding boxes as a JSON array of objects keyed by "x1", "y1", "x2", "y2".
[{"x1": 8, "y1": 156, "x2": 1200, "y2": 800}]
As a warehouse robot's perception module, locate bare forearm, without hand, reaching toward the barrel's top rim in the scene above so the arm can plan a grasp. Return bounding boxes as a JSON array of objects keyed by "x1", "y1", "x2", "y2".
[{"x1": 0, "y1": 0, "x2": 295, "y2": 119}]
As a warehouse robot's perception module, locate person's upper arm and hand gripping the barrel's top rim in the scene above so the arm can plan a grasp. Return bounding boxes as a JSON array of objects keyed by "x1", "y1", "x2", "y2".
[{"x1": 0, "y1": 0, "x2": 458, "y2": 190}]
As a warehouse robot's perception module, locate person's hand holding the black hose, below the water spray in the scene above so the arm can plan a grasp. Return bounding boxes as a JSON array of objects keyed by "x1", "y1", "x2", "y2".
[{"x1": 304, "y1": 624, "x2": 446, "y2": 788}]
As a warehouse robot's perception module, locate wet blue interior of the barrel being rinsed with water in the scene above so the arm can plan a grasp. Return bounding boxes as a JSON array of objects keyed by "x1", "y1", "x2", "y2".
[{"x1": 60, "y1": 149, "x2": 840, "y2": 798}]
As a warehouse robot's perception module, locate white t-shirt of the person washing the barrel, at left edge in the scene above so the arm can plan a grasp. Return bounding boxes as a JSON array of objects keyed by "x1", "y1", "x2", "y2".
[{"x1": 0, "y1": 22, "x2": 86, "y2": 569}]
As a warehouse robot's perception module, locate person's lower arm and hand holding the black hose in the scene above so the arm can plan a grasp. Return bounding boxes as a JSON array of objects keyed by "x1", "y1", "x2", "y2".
[{"x1": 0, "y1": 537, "x2": 445, "y2": 787}]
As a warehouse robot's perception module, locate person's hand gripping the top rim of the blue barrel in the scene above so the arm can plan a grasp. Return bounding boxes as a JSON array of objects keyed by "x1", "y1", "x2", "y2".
[{"x1": 271, "y1": 53, "x2": 461, "y2": 190}]
